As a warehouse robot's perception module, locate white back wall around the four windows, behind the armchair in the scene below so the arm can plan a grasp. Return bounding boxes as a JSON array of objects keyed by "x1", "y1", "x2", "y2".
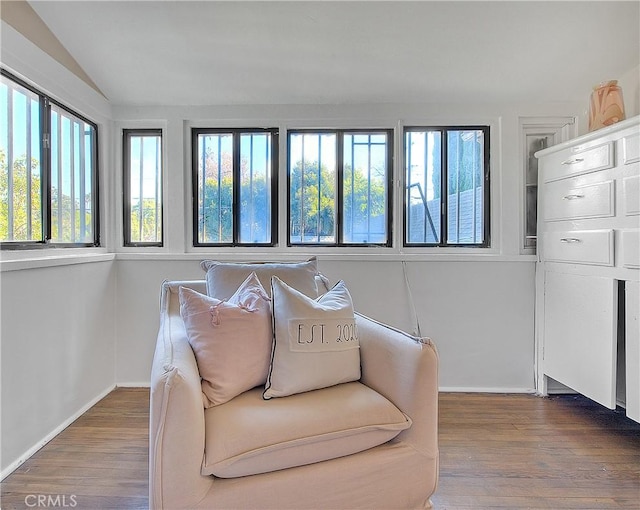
[{"x1": 114, "y1": 100, "x2": 581, "y2": 391}]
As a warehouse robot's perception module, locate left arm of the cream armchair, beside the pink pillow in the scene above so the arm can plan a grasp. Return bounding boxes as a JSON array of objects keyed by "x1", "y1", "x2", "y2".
[{"x1": 149, "y1": 282, "x2": 211, "y2": 509}]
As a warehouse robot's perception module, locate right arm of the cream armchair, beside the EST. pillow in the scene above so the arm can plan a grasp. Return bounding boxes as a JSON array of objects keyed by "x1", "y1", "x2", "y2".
[{"x1": 356, "y1": 314, "x2": 438, "y2": 458}]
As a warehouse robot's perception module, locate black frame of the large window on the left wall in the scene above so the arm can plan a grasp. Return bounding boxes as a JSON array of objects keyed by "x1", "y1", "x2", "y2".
[{"x1": 0, "y1": 68, "x2": 100, "y2": 250}]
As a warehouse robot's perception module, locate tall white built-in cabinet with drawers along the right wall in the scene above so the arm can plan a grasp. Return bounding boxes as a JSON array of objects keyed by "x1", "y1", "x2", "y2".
[{"x1": 536, "y1": 117, "x2": 640, "y2": 421}]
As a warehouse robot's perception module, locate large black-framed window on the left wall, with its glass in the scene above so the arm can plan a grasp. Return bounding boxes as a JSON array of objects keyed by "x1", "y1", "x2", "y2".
[{"x1": 0, "y1": 70, "x2": 98, "y2": 248}]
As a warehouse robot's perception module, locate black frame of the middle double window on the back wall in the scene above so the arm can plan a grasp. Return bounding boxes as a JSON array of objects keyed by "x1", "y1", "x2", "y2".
[{"x1": 287, "y1": 128, "x2": 395, "y2": 248}]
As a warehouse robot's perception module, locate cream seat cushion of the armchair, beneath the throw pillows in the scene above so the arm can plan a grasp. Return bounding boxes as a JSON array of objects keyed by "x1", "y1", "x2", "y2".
[{"x1": 202, "y1": 382, "x2": 411, "y2": 478}]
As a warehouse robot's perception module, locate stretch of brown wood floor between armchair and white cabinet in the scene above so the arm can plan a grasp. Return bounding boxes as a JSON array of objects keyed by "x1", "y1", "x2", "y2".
[{"x1": 433, "y1": 394, "x2": 640, "y2": 510}]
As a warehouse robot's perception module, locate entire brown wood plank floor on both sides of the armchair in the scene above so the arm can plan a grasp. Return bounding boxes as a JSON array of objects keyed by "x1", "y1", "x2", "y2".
[{"x1": 1, "y1": 388, "x2": 640, "y2": 510}]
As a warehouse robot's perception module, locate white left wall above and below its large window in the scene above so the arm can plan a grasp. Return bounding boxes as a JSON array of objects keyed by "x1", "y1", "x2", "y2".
[{"x1": 0, "y1": 22, "x2": 116, "y2": 476}]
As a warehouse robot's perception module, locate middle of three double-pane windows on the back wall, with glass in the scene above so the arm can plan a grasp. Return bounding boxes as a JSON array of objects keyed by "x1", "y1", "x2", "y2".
[{"x1": 288, "y1": 130, "x2": 393, "y2": 246}]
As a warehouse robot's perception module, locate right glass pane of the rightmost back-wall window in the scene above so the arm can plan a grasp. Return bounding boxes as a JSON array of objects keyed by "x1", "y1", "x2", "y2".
[{"x1": 447, "y1": 130, "x2": 484, "y2": 244}]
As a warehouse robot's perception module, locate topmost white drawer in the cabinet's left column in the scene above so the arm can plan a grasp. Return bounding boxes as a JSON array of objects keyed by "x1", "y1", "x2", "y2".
[{"x1": 543, "y1": 142, "x2": 614, "y2": 182}]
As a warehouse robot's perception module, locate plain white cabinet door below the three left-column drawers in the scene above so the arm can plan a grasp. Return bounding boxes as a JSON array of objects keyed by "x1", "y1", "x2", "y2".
[{"x1": 543, "y1": 271, "x2": 617, "y2": 409}]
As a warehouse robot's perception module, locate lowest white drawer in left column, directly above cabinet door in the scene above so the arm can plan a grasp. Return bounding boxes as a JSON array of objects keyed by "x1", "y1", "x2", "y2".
[{"x1": 542, "y1": 229, "x2": 613, "y2": 266}]
